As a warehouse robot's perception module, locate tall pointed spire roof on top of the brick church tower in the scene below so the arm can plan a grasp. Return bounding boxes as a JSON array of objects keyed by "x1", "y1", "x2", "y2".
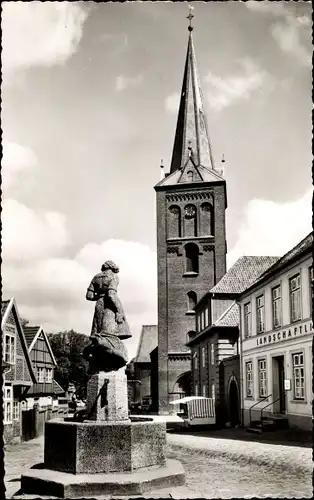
[{"x1": 157, "y1": 22, "x2": 224, "y2": 187}]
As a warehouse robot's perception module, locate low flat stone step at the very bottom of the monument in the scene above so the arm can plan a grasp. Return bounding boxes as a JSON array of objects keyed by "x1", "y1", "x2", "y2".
[{"x1": 21, "y1": 460, "x2": 185, "y2": 498}]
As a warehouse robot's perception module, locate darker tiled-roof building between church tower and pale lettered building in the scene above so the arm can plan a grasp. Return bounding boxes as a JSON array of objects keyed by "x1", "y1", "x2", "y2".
[{"x1": 187, "y1": 256, "x2": 278, "y2": 426}]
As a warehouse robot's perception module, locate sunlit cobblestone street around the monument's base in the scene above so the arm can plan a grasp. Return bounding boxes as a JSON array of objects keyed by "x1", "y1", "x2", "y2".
[{"x1": 5, "y1": 434, "x2": 313, "y2": 499}]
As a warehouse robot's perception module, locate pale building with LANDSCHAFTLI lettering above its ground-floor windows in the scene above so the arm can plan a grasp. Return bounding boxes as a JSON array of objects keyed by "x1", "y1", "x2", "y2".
[{"x1": 238, "y1": 233, "x2": 313, "y2": 430}]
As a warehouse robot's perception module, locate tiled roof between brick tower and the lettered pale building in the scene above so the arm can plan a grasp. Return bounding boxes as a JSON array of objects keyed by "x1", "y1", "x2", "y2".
[{"x1": 210, "y1": 256, "x2": 279, "y2": 295}]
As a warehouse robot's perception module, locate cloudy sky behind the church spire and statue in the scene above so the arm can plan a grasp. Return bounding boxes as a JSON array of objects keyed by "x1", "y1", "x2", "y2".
[{"x1": 1, "y1": 1, "x2": 312, "y2": 357}]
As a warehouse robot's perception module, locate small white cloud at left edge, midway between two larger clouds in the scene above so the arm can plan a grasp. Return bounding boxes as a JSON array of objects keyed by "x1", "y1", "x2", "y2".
[{"x1": 1, "y1": 141, "x2": 38, "y2": 193}]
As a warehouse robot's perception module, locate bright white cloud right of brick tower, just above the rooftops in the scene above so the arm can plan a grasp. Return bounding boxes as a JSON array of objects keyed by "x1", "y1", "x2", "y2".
[{"x1": 227, "y1": 190, "x2": 312, "y2": 267}]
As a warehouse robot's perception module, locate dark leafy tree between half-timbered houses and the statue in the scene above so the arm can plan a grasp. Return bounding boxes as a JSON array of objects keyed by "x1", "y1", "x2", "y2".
[{"x1": 48, "y1": 330, "x2": 89, "y2": 399}]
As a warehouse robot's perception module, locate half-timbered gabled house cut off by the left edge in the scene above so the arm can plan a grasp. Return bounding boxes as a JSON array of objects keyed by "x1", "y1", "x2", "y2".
[{"x1": 1, "y1": 298, "x2": 36, "y2": 443}]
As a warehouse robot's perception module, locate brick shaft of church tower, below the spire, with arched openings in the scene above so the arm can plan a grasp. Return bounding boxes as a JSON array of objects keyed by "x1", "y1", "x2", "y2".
[{"x1": 156, "y1": 183, "x2": 226, "y2": 412}]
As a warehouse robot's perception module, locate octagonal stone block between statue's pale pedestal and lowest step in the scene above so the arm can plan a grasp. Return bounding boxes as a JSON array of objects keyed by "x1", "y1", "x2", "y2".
[{"x1": 45, "y1": 421, "x2": 166, "y2": 474}]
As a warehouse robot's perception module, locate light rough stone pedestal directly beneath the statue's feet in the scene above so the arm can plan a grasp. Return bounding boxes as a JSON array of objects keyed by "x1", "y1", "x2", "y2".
[{"x1": 86, "y1": 368, "x2": 129, "y2": 422}]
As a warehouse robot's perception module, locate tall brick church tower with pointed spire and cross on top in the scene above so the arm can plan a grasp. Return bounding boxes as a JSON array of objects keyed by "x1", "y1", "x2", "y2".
[{"x1": 155, "y1": 12, "x2": 227, "y2": 413}]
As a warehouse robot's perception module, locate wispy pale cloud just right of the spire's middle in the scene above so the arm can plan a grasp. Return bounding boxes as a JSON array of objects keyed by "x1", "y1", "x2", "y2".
[{"x1": 205, "y1": 59, "x2": 271, "y2": 111}]
